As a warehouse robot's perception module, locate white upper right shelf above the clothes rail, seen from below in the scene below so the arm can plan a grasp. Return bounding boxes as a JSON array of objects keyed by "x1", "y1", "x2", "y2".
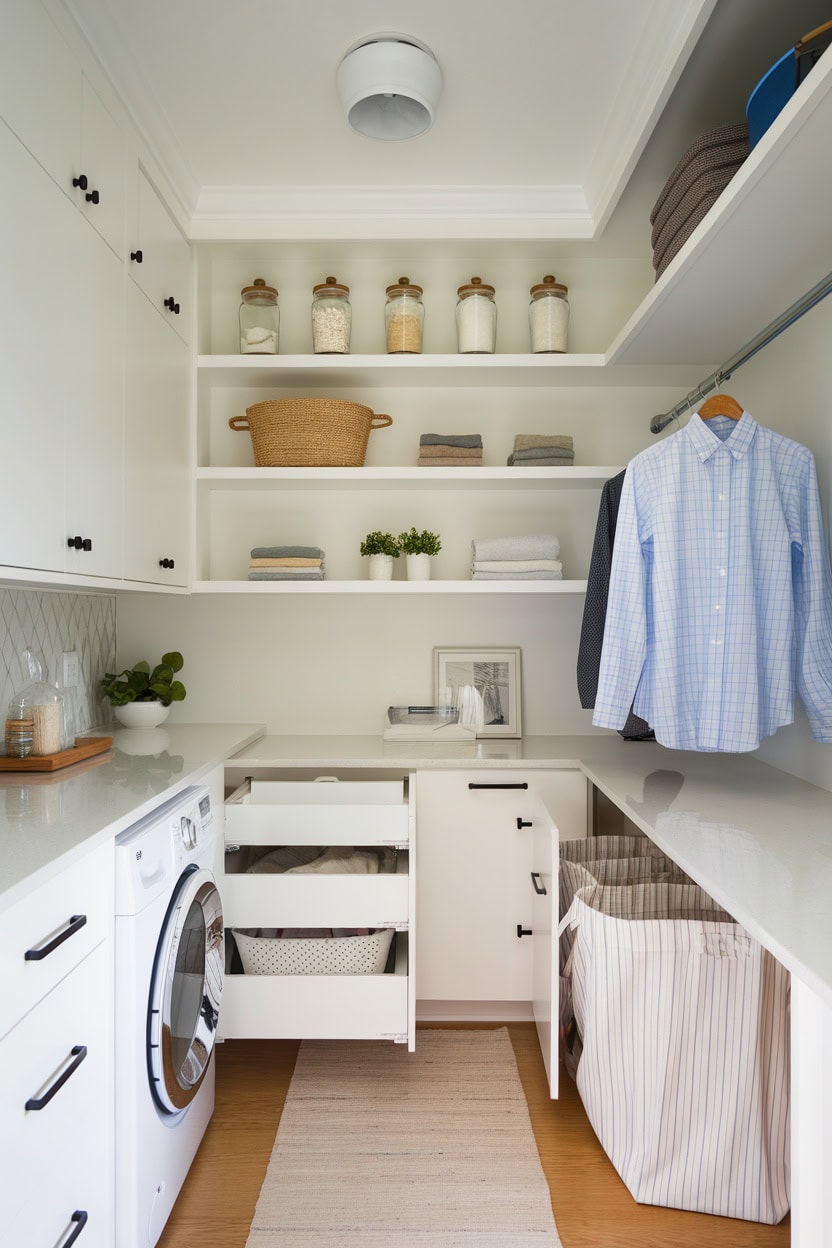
[{"x1": 606, "y1": 49, "x2": 832, "y2": 371}]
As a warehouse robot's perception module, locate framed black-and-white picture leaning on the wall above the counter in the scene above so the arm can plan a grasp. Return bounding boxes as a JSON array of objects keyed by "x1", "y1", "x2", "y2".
[{"x1": 433, "y1": 646, "x2": 520, "y2": 736}]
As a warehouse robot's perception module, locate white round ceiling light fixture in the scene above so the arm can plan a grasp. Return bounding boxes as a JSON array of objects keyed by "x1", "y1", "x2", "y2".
[{"x1": 337, "y1": 35, "x2": 442, "y2": 142}]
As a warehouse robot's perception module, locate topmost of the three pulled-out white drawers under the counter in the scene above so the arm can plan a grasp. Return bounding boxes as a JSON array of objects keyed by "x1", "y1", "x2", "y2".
[{"x1": 225, "y1": 778, "x2": 409, "y2": 846}]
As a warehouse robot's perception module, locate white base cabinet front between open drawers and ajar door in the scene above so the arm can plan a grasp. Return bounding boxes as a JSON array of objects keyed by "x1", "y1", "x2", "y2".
[{"x1": 417, "y1": 768, "x2": 586, "y2": 1017}]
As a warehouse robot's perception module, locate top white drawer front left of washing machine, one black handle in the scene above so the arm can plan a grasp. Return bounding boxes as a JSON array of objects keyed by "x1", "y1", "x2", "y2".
[{"x1": 0, "y1": 844, "x2": 114, "y2": 1043}]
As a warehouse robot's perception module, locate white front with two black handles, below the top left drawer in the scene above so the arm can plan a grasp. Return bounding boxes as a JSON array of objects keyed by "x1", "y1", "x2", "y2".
[{"x1": 0, "y1": 945, "x2": 112, "y2": 1248}]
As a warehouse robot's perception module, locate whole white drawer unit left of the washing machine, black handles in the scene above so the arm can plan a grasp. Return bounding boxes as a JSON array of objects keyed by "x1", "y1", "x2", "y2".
[{"x1": 0, "y1": 845, "x2": 114, "y2": 1248}]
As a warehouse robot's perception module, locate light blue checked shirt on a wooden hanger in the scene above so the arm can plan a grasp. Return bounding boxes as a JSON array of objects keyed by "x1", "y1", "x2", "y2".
[{"x1": 593, "y1": 412, "x2": 832, "y2": 753}]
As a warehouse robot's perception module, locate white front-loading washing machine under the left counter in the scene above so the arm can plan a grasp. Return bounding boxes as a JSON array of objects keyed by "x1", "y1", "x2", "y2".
[{"x1": 115, "y1": 787, "x2": 223, "y2": 1248}]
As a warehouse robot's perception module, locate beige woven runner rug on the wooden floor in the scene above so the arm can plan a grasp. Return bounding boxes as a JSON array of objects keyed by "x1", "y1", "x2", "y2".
[{"x1": 246, "y1": 1027, "x2": 560, "y2": 1248}]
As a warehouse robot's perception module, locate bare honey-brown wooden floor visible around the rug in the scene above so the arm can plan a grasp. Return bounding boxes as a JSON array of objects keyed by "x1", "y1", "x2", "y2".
[{"x1": 158, "y1": 1023, "x2": 790, "y2": 1248}]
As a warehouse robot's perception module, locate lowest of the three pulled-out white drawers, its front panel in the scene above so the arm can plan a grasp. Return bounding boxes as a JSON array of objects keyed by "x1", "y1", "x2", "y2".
[{"x1": 218, "y1": 932, "x2": 414, "y2": 1048}]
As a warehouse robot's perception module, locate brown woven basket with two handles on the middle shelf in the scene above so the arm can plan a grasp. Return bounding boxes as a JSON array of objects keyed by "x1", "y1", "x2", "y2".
[{"x1": 228, "y1": 398, "x2": 393, "y2": 468}]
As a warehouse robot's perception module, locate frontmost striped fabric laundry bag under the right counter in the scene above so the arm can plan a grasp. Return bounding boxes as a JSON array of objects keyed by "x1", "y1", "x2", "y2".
[{"x1": 561, "y1": 884, "x2": 790, "y2": 1223}]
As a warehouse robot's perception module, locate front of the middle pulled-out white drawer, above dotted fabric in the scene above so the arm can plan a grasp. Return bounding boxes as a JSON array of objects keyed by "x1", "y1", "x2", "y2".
[{"x1": 222, "y1": 854, "x2": 409, "y2": 927}]
